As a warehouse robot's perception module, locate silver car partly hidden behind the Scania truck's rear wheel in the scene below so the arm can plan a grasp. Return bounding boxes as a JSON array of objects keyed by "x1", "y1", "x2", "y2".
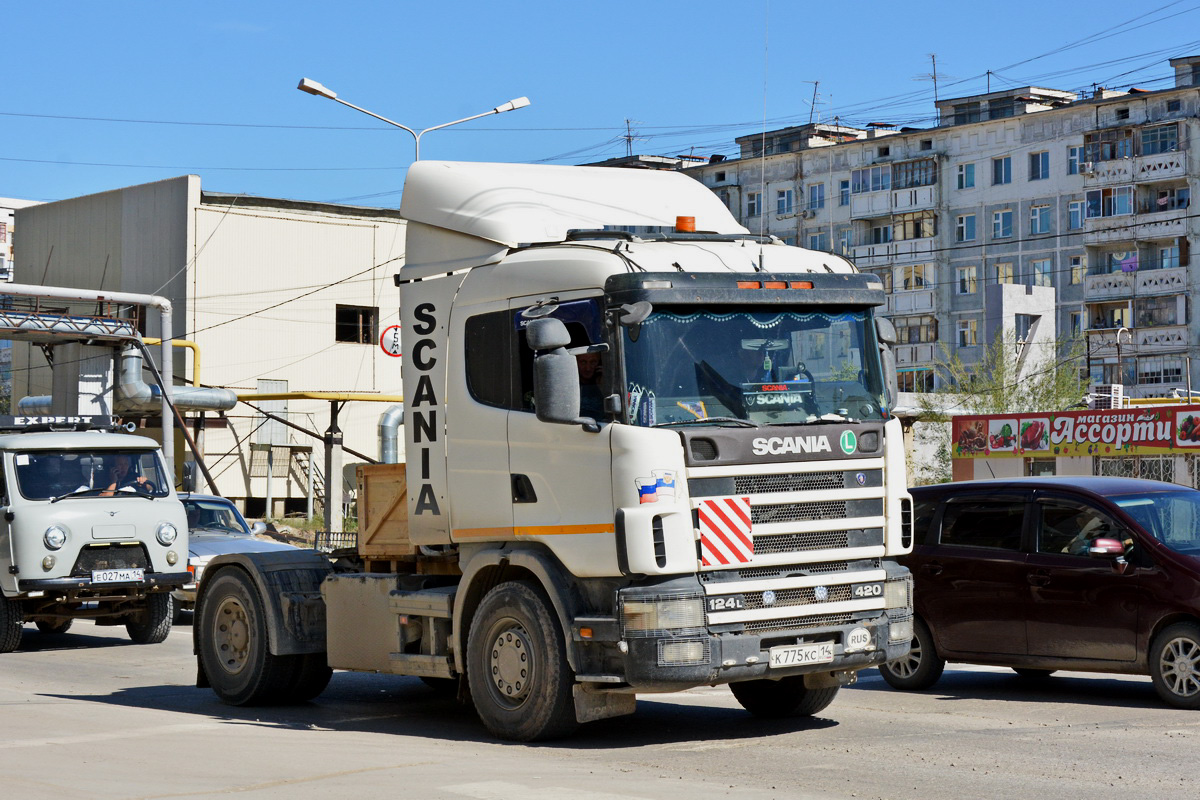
[{"x1": 172, "y1": 493, "x2": 295, "y2": 609}]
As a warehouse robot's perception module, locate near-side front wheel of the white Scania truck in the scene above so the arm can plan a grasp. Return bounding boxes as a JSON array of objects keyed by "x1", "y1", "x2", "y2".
[{"x1": 467, "y1": 582, "x2": 578, "y2": 741}]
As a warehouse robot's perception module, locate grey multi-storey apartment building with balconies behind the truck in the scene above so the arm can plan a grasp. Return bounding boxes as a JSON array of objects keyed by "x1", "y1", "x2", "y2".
[{"x1": 686, "y1": 56, "x2": 1200, "y2": 397}]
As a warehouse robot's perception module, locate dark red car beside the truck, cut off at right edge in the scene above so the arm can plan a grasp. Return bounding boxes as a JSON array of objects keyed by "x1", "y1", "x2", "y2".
[{"x1": 881, "y1": 477, "x2": 1200, "y2": 709}]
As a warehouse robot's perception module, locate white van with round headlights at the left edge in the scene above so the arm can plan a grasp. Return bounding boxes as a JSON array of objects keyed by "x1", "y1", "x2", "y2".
[{"x1": 0, "y1": 417, "x2": 188, "y2": 652}]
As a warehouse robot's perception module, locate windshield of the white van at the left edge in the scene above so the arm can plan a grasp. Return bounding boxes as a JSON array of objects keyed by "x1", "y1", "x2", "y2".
[{"x1": 13, "y1": 450, "x2": 170, "y2": 500}]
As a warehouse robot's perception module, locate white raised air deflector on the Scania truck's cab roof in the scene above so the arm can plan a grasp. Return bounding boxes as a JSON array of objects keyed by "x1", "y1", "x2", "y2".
[{"x1": 400, "y1": 161, "x2": 748, "y2": 247}]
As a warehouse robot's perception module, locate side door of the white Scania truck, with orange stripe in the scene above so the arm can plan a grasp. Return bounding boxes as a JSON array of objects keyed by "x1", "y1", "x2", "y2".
[{"x1": 509, "y1": 293, "x2": 616, "y2": 577}]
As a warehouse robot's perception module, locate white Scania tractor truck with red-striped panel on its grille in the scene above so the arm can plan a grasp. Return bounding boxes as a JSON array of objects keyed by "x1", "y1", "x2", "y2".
[{"x1": 194, "y1": 162, "x2": 912, "y2": 740}]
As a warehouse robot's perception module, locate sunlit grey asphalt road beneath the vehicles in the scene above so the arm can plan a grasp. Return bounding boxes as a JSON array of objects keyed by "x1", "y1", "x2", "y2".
[{"x1": 0, "y1": 622, "x2": 1200, "y2": 800}]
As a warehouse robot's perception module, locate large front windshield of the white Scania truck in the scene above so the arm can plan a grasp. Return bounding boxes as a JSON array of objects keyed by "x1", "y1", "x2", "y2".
[{"x1": 624, "y1": 307, "x2": 884, "y2": 426}]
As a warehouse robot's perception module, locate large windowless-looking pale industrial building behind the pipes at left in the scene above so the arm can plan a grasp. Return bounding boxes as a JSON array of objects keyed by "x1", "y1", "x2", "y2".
[{"x1": 13, "y1": 175, "x2": 404, "y2": 517}]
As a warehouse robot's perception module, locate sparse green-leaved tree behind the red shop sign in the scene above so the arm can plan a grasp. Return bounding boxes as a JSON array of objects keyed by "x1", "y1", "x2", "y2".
[{"x1": 912, "y1": 338, "x2": 1088, "y2": 483}]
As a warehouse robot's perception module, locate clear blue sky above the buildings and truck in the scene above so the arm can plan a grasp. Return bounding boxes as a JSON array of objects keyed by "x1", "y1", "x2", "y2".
[{"x1": 7, "y1": 0, "x2": 1200, "y2": 206}]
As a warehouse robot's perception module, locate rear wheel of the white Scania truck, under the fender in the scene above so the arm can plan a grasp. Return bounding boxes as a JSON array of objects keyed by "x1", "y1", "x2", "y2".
[{"x1": 199, "y1": 569, "x2": 295, "y2": 705}]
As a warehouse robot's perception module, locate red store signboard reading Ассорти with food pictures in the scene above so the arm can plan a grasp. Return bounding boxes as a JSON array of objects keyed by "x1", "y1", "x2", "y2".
[{"x1": 952, "y1": 405, "x2": 1200, "y2": 458}]
